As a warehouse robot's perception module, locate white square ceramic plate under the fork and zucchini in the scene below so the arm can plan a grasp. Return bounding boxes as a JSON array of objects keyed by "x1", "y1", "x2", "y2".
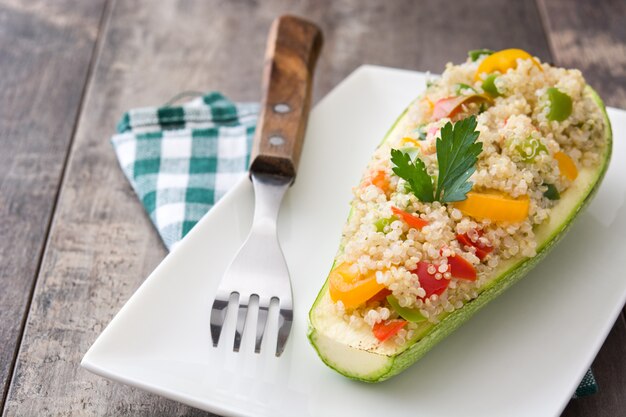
[{"x1": 82, "y1": 66, "x2": 626, "y2": 417}]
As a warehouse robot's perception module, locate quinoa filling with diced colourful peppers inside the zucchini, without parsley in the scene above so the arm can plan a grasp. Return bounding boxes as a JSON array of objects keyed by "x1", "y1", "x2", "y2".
[{"x1": 329, "y1": 50, "x2": 605, "y2": 346}]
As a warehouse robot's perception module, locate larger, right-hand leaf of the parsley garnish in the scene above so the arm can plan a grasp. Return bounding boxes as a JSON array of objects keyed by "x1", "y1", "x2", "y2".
[{"x1": 435, "y1": 116, "x2": 483, "y2": 203}]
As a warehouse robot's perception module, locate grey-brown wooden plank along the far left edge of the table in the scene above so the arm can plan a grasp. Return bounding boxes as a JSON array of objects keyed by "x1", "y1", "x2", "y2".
[{"x1": 0, "y1": 0, "x2": 104, "y2": 406}]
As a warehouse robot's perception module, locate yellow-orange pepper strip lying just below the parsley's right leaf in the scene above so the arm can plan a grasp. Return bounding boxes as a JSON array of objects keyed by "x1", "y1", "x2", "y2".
[{"x1": 454, "y1": 192, "x2": 530, "y2": 222}]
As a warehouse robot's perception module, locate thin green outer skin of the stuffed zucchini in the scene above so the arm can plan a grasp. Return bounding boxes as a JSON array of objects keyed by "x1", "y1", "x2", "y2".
[{"x1": 308, "y1": 85, "x2": 613, "y2": 383}]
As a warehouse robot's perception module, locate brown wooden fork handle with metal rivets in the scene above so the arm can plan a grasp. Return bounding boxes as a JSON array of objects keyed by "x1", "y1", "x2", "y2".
[{"x1": 250, "y1": 15, "x2": 322, "y2": 178}]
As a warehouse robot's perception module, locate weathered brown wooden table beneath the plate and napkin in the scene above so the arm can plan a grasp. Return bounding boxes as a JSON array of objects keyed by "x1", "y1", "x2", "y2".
[{"x1": 0, "y1": 0, "x2": 626, "y2": 416}]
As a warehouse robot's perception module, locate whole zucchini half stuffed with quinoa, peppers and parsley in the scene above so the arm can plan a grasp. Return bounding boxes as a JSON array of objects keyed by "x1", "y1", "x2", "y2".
[{"x1": 309, "y1": 49, "x2": 612, "y2": 382}]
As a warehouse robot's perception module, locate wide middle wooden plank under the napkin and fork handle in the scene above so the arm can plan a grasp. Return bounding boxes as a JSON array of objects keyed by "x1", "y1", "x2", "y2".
[{"x1": 4, "y1": 0, "x2": 549, "y2": 416}]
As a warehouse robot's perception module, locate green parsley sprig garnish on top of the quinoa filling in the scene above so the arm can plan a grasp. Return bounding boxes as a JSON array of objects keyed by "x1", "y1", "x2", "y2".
[{"x1": 391, "y1": 116, "x2": 483, "y2": 203}]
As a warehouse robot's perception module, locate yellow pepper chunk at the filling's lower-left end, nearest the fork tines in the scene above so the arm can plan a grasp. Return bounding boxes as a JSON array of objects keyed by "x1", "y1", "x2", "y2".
[{"x1": 328, "y1": 262, "x2": 385, "y2": 308}]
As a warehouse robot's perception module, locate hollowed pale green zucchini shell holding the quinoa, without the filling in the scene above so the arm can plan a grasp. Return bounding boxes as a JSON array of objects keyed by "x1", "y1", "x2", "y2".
[{"x1": 308, "y1": 86, "x2": 613, "y2": 382}]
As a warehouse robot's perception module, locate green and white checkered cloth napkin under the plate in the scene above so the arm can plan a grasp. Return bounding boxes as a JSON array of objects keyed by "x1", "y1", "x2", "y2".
[{"x1": 111, "y1": 92, "x2": 598, "y2": 398}]
